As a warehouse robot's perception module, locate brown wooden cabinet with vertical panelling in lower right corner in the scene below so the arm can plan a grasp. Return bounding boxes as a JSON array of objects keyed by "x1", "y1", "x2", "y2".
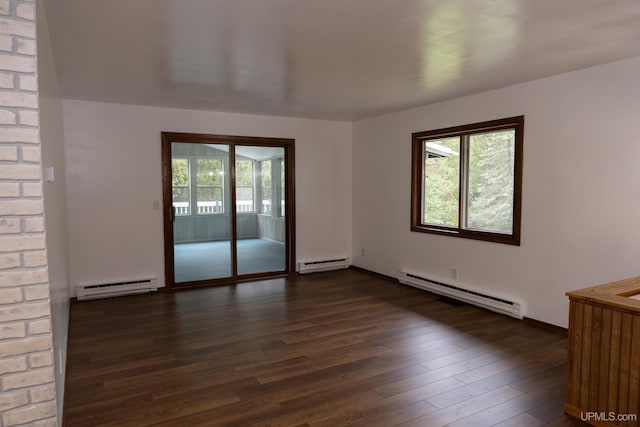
[{"x1": 565, "y1": 277, "x2": 640, "y2": 426}]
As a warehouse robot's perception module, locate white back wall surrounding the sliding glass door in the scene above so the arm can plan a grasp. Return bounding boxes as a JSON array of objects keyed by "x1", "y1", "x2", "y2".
[{"x1": 63, "y1": 100, "x2": 351, "y2": 294}]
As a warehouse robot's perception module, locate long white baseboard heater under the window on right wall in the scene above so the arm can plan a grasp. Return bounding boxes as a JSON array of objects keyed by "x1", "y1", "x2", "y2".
[{"x1": 398, "y1": 271, "x2": 524, "y2": 319}]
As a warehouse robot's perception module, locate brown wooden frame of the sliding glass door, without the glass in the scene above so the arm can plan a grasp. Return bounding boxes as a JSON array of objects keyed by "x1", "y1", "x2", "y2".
[{"x1": 162, "y1": 132, "x2": 296, "y2": 289}]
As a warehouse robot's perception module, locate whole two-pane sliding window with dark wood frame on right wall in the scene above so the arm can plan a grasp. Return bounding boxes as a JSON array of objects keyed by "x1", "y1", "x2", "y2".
[{"x1": 411, "y1": 116, "x2": 524, "y2": 245}]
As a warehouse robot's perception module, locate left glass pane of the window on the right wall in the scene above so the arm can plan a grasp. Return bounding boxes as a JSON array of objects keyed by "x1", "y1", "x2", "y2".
[{"x1": 422, "y1": 137, "x2": 460, "y2": 227}]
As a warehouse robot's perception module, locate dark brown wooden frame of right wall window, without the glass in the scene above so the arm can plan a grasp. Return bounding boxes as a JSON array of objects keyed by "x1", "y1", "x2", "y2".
[{"x1": 411, "y1": 116, "x2": 524, "y2": 246}]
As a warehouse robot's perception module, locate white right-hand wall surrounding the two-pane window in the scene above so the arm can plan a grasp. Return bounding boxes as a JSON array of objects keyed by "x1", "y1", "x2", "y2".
[{"x1": 352, "y1": 58, "x2": 640, "y2": 327}]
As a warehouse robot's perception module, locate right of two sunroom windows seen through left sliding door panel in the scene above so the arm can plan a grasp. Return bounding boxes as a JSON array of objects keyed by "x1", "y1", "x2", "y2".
[{"x1": 196, "y1": 159, "x2": 224, "y2": 215}]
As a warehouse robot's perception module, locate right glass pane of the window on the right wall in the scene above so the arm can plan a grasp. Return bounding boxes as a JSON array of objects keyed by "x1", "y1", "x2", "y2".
[{"x1": 466, "y1": 129, "x2": 515, "y2": 234}]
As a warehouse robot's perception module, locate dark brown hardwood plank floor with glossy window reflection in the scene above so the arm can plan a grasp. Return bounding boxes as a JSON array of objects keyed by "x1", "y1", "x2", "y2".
[{"x1": 64, "y1": 270, "x2": 583, "y2": 427}]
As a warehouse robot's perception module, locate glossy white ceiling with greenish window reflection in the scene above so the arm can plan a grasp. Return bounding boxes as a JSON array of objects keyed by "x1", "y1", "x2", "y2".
[{"x1": 45, "y1": 0, "x2": 640, "y2": 120}]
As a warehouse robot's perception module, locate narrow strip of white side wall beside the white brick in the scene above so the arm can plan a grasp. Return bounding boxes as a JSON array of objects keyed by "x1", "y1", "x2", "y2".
[{"x1": 37, "y1": 1, "x2": 69, "y2": 423}]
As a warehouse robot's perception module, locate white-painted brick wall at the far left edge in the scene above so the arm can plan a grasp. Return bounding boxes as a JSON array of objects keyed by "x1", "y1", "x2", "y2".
[{"x1": 0, "y1": 0, "x2": 56, "y2": 427}]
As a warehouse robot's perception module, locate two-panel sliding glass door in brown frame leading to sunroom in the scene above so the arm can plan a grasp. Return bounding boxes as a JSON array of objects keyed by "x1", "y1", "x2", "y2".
[{"x1": 163, "y1": 133, "x2": 295, "y2": 287}]
